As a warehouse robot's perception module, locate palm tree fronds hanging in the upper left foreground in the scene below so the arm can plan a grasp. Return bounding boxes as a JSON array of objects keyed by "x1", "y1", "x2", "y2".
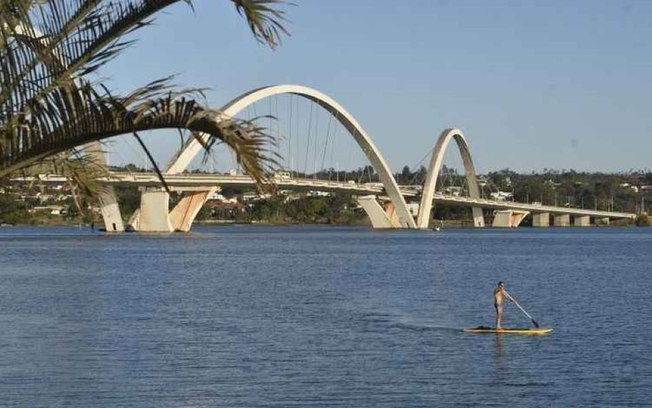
[{"x1": 0, "y1": 0, "x2": 287, "y2": 186}]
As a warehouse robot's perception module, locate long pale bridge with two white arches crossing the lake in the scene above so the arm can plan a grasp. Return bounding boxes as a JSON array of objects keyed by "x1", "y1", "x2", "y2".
[{"x1": 75, "y1": 85, "x2": 636, "y2": 232}]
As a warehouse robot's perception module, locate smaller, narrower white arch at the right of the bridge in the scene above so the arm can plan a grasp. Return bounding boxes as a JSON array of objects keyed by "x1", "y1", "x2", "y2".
[{"x1": 417, "y1": 129, "x2": 484, "y2": 228}]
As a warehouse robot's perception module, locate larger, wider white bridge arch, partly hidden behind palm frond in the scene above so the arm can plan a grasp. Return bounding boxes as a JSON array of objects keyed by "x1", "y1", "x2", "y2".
[{"x1": 165, "y1": 85, "x2": 416, "y2": 228}]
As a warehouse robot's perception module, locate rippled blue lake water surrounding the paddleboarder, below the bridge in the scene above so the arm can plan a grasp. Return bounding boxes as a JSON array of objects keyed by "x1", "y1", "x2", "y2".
[{"x1": 0, "y1": 226, "x2": 652, "y2": 408}]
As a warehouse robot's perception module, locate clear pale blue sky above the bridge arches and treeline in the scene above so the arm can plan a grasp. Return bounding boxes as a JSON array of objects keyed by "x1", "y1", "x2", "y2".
[{"x1": 103, "y1": 0, "x2": 652, "y2": 172}]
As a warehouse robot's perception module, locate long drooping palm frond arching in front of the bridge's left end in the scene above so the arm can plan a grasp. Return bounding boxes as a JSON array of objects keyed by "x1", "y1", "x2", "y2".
[{"x1": 0, "y1": 81, "x2": 276, "y2": 182}]
